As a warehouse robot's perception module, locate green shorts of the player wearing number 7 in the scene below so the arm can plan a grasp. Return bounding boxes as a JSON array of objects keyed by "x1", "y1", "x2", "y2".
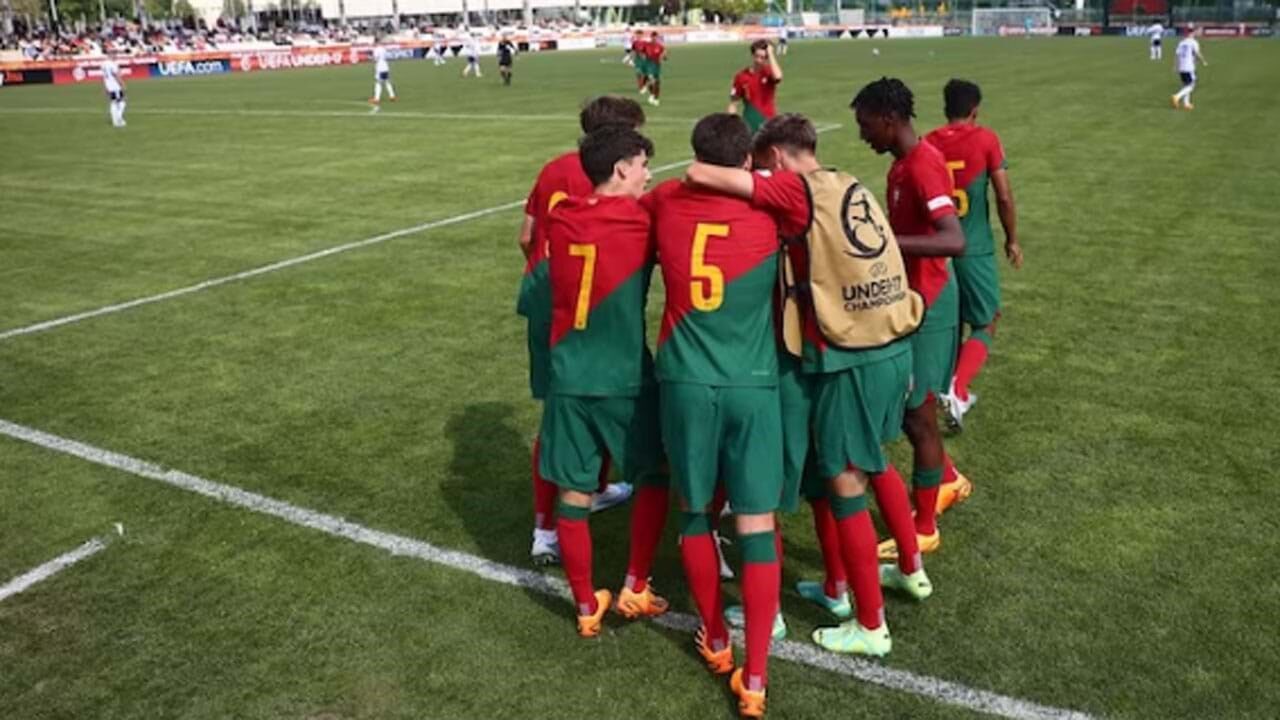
[{"x1": 539, "y1": 386, "x2": 667, "y2": 493}]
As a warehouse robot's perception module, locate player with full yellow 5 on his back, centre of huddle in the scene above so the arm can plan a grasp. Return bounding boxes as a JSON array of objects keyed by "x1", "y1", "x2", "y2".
[{"x1": 645, "y1": 113, "x2": 782, "y2": 717}]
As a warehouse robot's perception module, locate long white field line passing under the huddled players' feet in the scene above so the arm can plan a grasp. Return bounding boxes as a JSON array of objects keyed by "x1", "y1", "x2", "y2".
[{"x1": 0, "y1": 420, "x2": 1092, "y2": 720}]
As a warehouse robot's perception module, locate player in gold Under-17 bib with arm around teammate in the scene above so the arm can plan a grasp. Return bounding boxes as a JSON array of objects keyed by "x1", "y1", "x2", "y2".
[{"x1": 689, "y1": 114, "x2": 932, "y2": 656}]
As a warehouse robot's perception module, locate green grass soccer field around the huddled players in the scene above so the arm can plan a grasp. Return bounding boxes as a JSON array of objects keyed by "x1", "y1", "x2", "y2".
[{"x1": 0, "y1": 38, "x2": 1280, "y2": 720}]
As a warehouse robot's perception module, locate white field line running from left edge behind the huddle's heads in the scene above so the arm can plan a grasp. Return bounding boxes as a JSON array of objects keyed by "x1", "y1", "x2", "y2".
[{"x1": 0, "y1": 126, "x2": 840, "y2": 342}]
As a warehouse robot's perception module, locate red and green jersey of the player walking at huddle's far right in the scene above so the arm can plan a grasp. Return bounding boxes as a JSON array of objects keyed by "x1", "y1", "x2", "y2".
[{"x1": 925, "y1": 123, "x2": 1009, "y2": 255}]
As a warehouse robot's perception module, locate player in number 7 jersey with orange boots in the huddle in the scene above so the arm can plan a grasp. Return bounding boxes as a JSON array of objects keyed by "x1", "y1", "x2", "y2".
[{"x1": 540, "y1": 126, "x2": 667, "y2": 637}]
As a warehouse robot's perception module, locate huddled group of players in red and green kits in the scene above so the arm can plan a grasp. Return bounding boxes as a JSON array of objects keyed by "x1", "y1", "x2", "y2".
[{"x1": 517, "y1": 37, "x2": 1023, "y2": 717}]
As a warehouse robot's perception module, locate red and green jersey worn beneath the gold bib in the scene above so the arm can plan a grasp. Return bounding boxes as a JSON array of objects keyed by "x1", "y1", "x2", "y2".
[{"x1": 751, "y1": 170, "x2": 910, "y2": 373}]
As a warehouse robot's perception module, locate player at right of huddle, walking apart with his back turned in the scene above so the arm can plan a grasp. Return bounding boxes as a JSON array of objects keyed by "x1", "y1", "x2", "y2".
[{"x1": 925, "y1": 79, "x2": 1023, "y2": 428}]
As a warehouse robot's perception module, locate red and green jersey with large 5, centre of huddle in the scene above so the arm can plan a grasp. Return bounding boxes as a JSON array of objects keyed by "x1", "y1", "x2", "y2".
[{"x1": 641, "y1": 179, "x2": 778, "y2": 386}]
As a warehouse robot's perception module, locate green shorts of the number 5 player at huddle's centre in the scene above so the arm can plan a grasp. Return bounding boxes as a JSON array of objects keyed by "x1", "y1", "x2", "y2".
[{"x1": 662, "y1": 383, "x2": 782, "y2": 515}]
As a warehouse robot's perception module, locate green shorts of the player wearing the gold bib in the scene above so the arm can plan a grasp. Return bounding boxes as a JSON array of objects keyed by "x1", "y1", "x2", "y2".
[{"x1": 806, "y1": 343, "x2": 911, "y2": 479}]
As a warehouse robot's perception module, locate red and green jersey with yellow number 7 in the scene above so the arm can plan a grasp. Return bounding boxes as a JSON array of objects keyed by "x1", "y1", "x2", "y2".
[{"x1": 547, "y1": 195, "x2": 654, "y2": 397}]
